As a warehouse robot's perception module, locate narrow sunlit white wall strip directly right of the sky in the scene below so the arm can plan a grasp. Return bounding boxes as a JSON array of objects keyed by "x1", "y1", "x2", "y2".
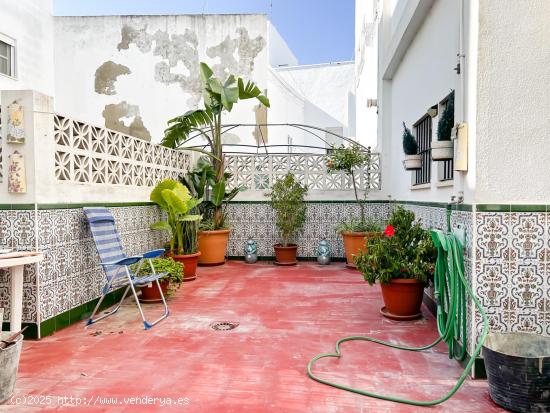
[{"x1": 353, "y1": 0, "x2": 378, "y2": 150}]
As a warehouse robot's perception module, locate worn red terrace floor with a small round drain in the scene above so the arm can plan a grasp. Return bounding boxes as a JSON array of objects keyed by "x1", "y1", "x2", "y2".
[{"x1": 0, "y1": 262, "x2": 502, "y2": 413}]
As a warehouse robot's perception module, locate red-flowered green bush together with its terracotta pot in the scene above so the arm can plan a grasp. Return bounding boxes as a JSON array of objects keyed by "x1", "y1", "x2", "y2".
[{"x1": 355, "y1": 206, "x2": 436, "y2": 319}]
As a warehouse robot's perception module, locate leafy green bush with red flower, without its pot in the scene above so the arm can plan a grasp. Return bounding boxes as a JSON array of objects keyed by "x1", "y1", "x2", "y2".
[{"x1": 355, "y1": 206, "x2": 436, "y2": 285}]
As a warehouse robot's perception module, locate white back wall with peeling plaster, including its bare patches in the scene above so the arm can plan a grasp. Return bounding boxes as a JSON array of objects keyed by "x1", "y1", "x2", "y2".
[{"x1": 55, "y1": 15, "x2": 269, "y2": 144}]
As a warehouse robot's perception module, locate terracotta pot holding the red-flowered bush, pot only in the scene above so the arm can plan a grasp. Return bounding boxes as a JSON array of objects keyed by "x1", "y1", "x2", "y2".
[{"x1": 380, "y1": 278, "x2": 424, "y2": 317}]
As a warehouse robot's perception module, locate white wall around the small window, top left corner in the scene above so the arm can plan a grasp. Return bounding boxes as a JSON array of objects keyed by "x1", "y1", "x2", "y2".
[{"x1": 0, "y1": 0, "x2": 54, "y2": 95}]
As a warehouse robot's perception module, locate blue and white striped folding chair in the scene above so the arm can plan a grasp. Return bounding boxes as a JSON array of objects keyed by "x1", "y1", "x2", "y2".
[{"x1": 83, "y1": 207, "x2": 169, "y2": 330}]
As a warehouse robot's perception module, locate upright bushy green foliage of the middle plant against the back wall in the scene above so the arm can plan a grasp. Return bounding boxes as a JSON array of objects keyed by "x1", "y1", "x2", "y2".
[{"x1": 266, "y1": 172, "x2": 307, "y2": 247}]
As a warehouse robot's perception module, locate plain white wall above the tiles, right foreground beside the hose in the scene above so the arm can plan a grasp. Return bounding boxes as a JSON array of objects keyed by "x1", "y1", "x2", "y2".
[{"x1": 476, "y1": 0, "x2": 550, "y2": 204}]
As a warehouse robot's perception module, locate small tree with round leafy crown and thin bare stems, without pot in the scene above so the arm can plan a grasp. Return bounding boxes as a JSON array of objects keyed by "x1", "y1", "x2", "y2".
[{"x1": 326, "y1": 144, "x2": 371, "y2": 225}]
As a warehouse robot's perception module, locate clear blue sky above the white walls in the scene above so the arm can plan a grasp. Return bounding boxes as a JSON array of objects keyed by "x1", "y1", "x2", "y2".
[{"x1": 54, "y1": 0, "x2": 355, "y2": 64}]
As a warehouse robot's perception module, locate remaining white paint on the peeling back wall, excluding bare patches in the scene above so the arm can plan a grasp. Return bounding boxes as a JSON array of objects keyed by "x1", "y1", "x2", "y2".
[{"x1": 55, "y1": 15, "x2": 269, "y2": 143}]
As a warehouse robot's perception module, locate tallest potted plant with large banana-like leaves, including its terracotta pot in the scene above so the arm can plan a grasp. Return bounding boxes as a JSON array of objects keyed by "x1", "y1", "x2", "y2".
[{"x1": 162, "y1": 63, "x2": 269, "y2": 265}]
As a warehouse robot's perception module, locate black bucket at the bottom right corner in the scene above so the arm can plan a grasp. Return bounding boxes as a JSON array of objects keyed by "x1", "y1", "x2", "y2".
[{"x1": 483, "y1": 332, "x2": 550, "y2": 412}]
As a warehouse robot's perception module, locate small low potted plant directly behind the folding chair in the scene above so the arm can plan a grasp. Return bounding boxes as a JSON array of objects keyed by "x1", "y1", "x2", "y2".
[{"x1": 136, "y1": 258, "x2": 185, "y2": 303}]
